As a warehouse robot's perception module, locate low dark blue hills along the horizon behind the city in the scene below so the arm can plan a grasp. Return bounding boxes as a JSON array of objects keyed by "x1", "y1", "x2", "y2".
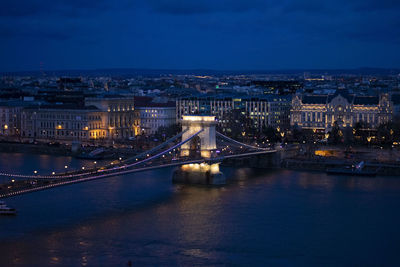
[{"x1": 0, "y1": 68, "x2": 400, "y2": 77}]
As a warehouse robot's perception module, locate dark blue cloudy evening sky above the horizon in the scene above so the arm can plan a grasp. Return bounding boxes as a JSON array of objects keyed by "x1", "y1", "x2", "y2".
[{"x1": 0, "y1": 0, "x2": 400, "y2": 71}]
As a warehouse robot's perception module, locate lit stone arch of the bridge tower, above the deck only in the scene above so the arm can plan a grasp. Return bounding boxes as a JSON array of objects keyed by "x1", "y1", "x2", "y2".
[{"x1": 181, "y1": 115, "x2": 217, "y2": 158}]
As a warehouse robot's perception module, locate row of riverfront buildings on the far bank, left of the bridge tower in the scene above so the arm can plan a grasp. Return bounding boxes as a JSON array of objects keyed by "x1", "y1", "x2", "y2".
[{"x1": 0, "y1": 95, "x2": 176, "y2": 142}]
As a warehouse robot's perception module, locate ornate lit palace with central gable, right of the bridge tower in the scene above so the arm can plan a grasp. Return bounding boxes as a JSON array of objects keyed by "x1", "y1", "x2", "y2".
[{"x1": 290, "y1": 90, "x2": 392, "y2": 132}]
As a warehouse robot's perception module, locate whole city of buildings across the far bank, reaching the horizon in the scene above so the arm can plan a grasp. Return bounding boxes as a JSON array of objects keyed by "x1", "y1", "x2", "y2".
[{"x1": 0, "y1": 73, "x2": 400, "y2": 143}]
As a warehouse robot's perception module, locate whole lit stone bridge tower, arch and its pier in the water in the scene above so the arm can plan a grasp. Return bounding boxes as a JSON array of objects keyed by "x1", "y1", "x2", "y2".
[{"x1": 172, "y1": 115, "x2": 226, "y2": 185}]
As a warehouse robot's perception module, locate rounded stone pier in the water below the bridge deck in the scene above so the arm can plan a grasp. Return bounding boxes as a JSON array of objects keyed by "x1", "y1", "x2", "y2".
[{"x1": 172, "y1": 163, "x2": 226, "y2": 185}]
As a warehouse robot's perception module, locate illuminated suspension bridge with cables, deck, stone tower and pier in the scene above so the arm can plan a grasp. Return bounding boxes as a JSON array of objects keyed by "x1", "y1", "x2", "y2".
[{"x1": 0, "y1": 115, "x2": 277, "y2": 198}]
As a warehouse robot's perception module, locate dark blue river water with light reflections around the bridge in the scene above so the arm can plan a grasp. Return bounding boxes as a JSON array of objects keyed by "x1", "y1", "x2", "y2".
[{"x1": 0, "y1": 154, "x2": 400, "y2": 266}]
